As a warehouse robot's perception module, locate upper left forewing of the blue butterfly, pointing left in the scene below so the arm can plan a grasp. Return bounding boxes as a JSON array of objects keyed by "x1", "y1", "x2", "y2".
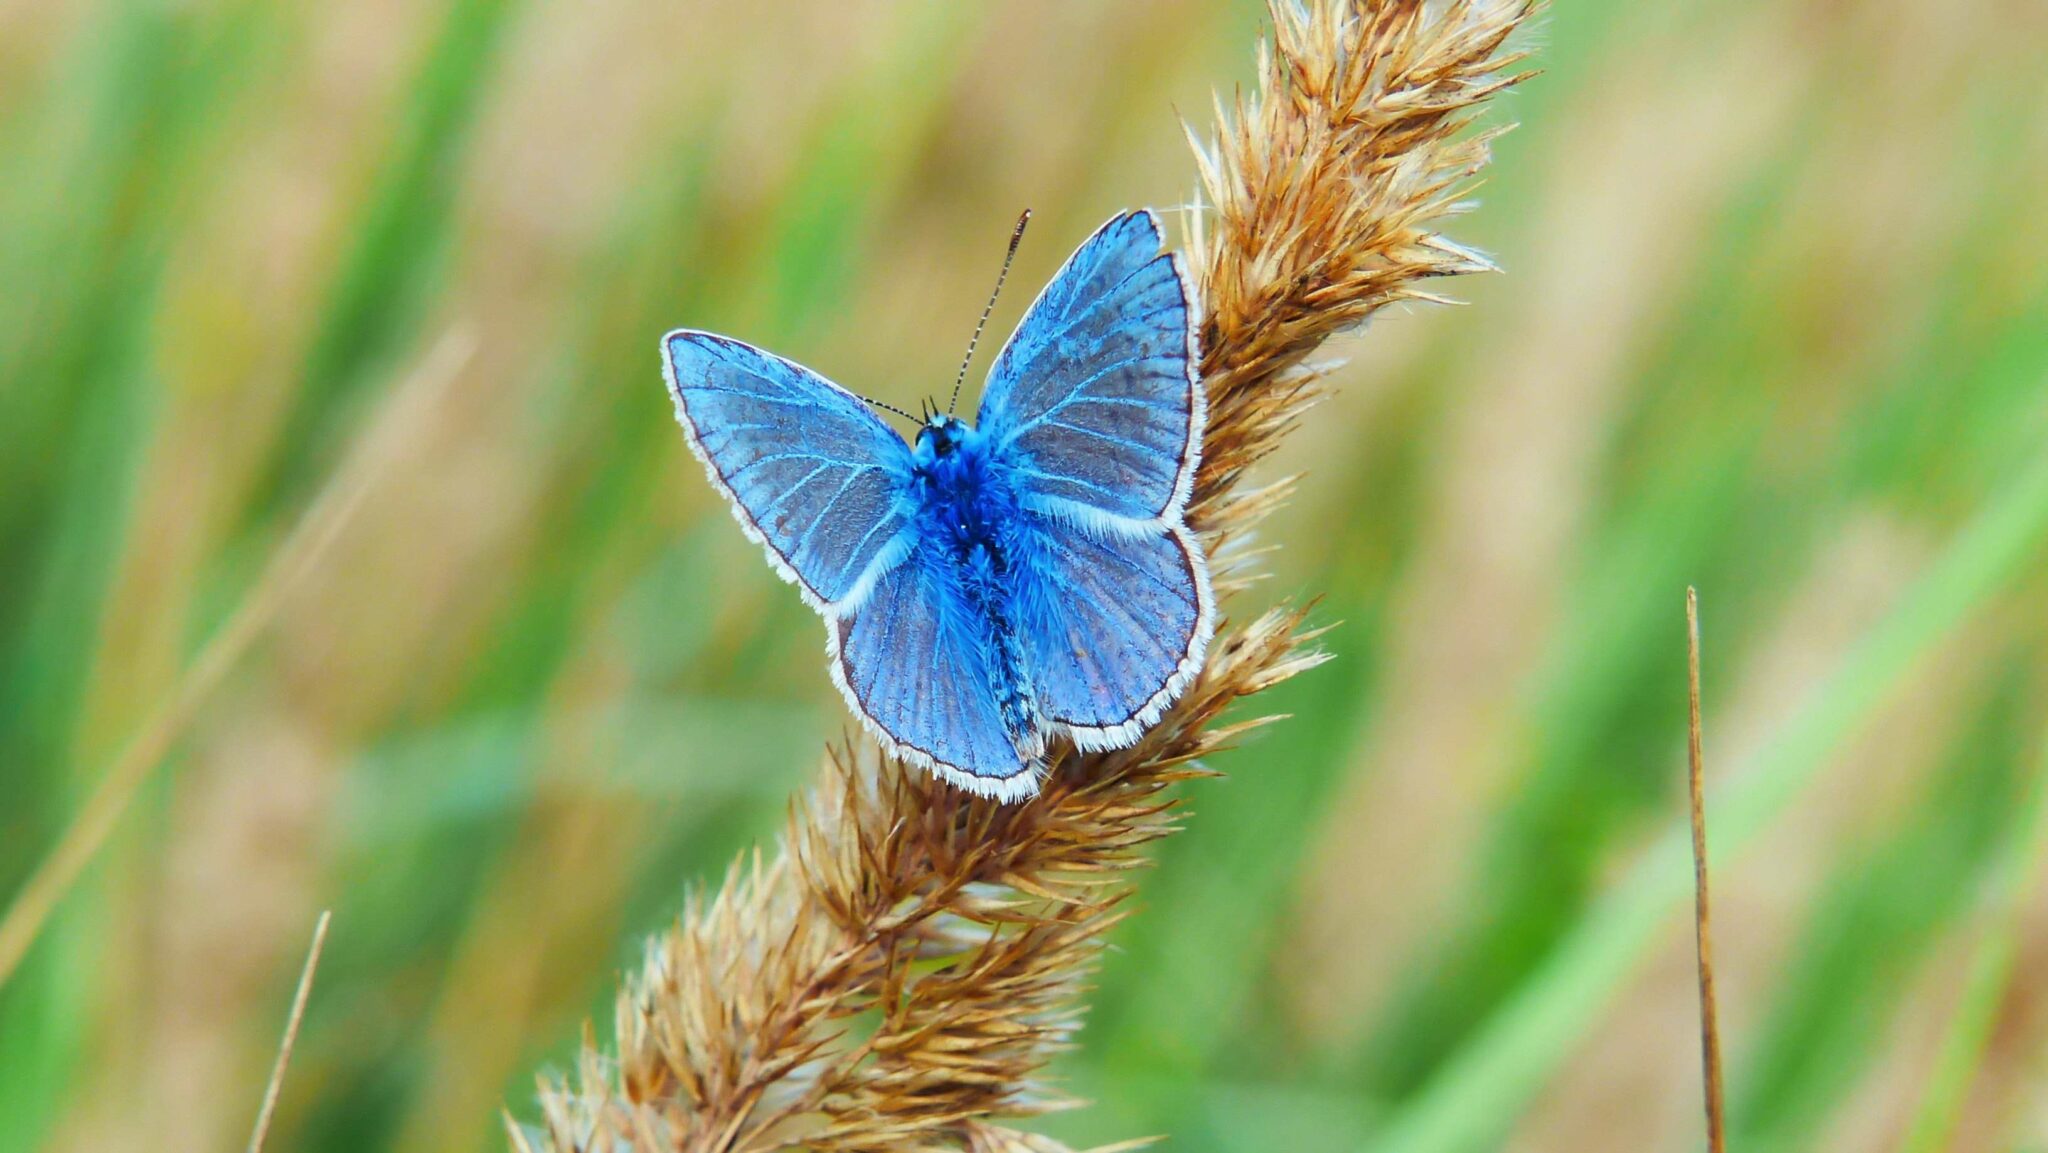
[{"x1": 662, "y1": 330, "x2": 911, "y2": 616}]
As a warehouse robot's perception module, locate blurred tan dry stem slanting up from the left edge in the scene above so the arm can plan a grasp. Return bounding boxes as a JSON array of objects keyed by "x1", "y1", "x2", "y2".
[{"x1": 0, "y1": 332, "x2": 475, "y2": 985}]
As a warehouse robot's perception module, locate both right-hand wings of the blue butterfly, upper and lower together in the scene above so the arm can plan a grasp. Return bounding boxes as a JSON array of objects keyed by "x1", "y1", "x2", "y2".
[{"x1": 979, "y1": 213, "x2": 1214, "y2": 748}]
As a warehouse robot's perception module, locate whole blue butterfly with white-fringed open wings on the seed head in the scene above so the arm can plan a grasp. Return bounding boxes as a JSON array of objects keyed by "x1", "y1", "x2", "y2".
[{"x1": 662, "y1": 211, "x2": 1214, "y2": 801}]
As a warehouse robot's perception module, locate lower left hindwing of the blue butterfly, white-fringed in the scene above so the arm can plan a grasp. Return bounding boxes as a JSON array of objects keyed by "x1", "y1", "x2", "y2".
[{"x1": 831, "y1": 549, "x2": 1044, "y2": 801}]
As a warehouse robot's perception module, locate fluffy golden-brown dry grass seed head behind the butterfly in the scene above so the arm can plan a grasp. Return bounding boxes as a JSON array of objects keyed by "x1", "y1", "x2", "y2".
[{"x1": 512, "y1": 0, "x2": 1530, "y2": 1153}]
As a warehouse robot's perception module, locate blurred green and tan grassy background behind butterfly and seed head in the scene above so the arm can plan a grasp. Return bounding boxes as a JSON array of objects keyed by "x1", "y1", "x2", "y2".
[{"x1": 0, "y1": 0, "x2": 2048, "y2": 1153}]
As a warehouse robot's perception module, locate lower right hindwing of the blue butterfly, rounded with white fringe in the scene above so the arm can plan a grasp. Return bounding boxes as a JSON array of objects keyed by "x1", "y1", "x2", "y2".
[{"x1": 1016, "y1": 520, "x2": 1217, "y2": 750}]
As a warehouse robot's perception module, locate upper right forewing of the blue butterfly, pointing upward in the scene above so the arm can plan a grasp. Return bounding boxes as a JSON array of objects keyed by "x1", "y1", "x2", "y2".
[{"x1": 977, "y1": 211, "x2": 1204, "y2": 522}]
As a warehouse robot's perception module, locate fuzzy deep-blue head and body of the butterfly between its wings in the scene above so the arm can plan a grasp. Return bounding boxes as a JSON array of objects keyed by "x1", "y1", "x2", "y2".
[{"x1": 911, "y1": 416, "x2": 1038, "y2": 756}]
